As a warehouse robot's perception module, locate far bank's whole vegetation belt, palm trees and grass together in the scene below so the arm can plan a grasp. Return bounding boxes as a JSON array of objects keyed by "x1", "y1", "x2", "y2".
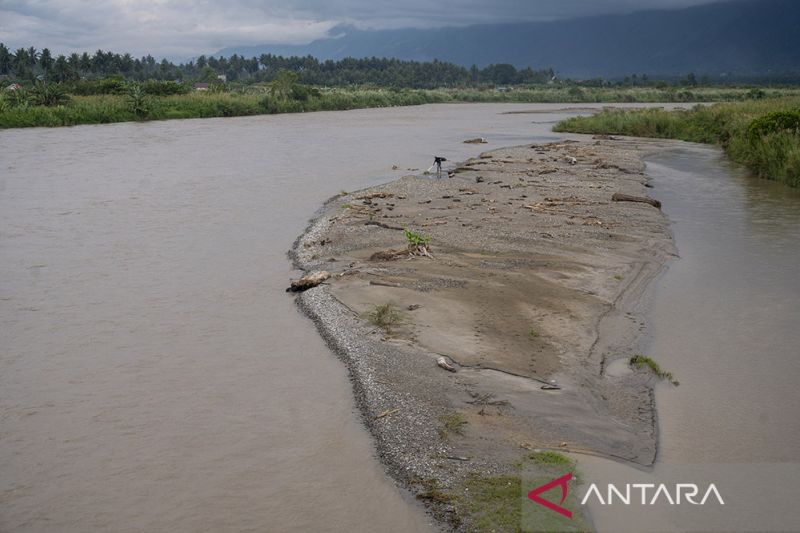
[{"x1": 0, "y1": 43, "x2": 800, "y2": 128}]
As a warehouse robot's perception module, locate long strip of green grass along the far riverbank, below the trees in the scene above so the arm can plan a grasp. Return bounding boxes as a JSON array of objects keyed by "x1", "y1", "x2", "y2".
[{"x1": 0, "y1": 79, "x2": 800, "y2": 128}]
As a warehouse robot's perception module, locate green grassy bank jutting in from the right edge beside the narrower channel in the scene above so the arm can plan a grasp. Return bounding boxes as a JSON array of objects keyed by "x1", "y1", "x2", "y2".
[{"x1": 553, "y1": 96, "x2": 800, "y2": 187}]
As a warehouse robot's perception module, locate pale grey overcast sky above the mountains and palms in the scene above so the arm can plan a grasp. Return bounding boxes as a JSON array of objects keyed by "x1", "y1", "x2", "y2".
[{"x1": 0, "y1": 0, "x2": 744, "y2": 58}]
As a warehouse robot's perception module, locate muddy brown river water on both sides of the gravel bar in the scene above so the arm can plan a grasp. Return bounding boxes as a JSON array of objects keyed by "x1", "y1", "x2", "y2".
[{"x1": 0, "y1": 105, "x2": 800, "y2": 532}]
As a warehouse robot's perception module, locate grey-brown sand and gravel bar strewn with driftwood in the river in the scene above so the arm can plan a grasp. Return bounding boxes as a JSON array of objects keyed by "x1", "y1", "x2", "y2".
[{"x1": 290, "y1": 138, "x2": 675, "y2": 530}]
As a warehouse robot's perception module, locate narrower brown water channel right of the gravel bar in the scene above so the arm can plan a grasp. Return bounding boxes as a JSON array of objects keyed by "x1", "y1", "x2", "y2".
[{"x1": 580, "y1": 143, "x2": 800, "y2": 532}]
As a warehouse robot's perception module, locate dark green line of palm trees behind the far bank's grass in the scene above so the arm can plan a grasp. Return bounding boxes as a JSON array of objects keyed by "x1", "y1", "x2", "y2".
[{"x1": 0, "y1": 43, "x2": 555, "y2": 89}]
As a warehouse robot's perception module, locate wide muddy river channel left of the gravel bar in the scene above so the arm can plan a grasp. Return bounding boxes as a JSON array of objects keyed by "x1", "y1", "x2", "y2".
[{"x1": 0, "y1": 105, "x2": 592, "y2": 532}]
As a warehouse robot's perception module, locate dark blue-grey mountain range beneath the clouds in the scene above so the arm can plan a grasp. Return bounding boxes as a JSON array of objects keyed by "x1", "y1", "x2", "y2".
[{"x1": 216, "y1": 0, "x2": 800, "y2": 78}]
